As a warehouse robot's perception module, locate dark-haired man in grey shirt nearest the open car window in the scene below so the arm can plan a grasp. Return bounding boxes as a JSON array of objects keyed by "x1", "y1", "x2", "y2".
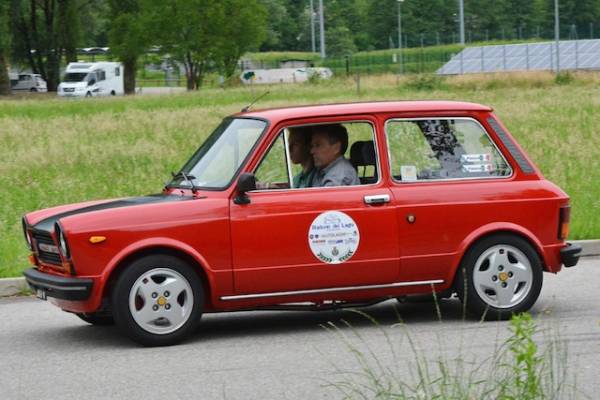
[{"x1": 310, "y1": 124, "x2": 360, "y2": 187}]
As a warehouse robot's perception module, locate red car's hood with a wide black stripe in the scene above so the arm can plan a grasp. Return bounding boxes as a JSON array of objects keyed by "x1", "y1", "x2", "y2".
[{"x1": 32, "y1": 193, "x2": 194, "y2": 232}]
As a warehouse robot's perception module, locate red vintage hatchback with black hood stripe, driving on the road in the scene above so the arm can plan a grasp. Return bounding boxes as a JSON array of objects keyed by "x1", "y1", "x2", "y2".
[{"x1": 23, "y1": 101, "x2": 581, "y2": 345}]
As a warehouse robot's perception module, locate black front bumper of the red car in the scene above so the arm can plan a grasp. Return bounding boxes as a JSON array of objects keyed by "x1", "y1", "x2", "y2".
[{"x1": 23, "y1": 268, "x2": 93, "y2": 300}]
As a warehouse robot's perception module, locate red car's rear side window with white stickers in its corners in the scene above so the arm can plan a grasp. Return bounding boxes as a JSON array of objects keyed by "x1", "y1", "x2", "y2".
[{"x1": 386, "y1": 118, "x2": 512, "y2": 182}]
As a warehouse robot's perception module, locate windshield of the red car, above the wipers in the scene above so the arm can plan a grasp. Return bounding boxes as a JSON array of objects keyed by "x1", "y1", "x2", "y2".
[{"x1": 169, "y1": 118, "x2": 267, "y2": 189}]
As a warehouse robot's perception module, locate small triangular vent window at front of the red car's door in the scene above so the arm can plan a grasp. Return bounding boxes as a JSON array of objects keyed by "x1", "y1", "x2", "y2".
[{"x1": 254, "y1": 131, "x2": 290, "y2": 189}]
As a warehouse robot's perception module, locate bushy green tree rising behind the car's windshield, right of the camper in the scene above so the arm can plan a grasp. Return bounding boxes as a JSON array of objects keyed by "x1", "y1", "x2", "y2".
[{"x1": 144, "y1": 0, "x2": 265, "y2": 90}]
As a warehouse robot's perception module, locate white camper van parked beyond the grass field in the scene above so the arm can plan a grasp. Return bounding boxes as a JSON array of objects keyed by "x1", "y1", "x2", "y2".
[{"x1": 58, "y1": 62, "x2": 125, "y2": 97}]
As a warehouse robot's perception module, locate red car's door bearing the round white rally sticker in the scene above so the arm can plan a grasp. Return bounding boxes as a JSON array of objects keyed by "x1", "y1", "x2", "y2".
[{"x1": 230, "y1": 121, "x2": 399, "y2": 294}]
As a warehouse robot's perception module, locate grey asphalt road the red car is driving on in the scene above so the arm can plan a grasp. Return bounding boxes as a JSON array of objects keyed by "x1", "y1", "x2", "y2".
[{"x1": 0, "y1": 258, "x2": 600, "y2": 400}]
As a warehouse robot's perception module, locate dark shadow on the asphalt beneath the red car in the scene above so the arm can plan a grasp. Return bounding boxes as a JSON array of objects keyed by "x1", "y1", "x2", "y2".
[{"x1": 32, "y1": 298, "x2": 528, "y2": 350}]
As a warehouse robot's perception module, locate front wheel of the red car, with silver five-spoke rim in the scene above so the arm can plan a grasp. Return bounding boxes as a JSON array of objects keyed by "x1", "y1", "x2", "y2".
[{"x1": 112, "y1": 255, "x2": 204, "y2": 346}]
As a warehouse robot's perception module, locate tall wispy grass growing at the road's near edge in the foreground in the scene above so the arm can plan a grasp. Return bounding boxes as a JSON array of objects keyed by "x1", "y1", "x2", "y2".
[{"x1": 326, "y1": 313, "x2": 585, "y2": 400}]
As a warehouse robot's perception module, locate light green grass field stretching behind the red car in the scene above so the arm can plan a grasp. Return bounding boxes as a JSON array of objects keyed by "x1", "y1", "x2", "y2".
[{"x1": 0, "y1": 73, "x2": 600, "y2": 277}]
